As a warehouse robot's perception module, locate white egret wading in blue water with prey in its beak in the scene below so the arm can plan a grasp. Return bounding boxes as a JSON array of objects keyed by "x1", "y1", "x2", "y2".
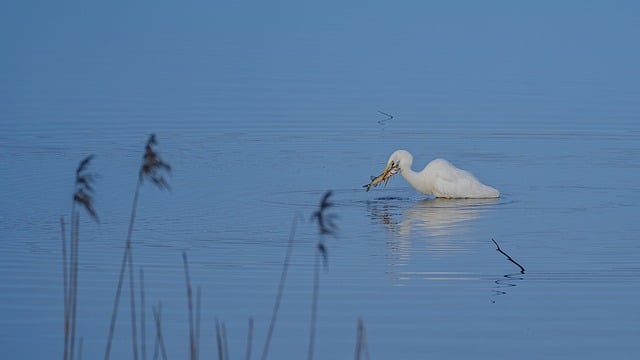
[{"x1": 364, "y1": 150, "x2": 500, "y2": 199}]
